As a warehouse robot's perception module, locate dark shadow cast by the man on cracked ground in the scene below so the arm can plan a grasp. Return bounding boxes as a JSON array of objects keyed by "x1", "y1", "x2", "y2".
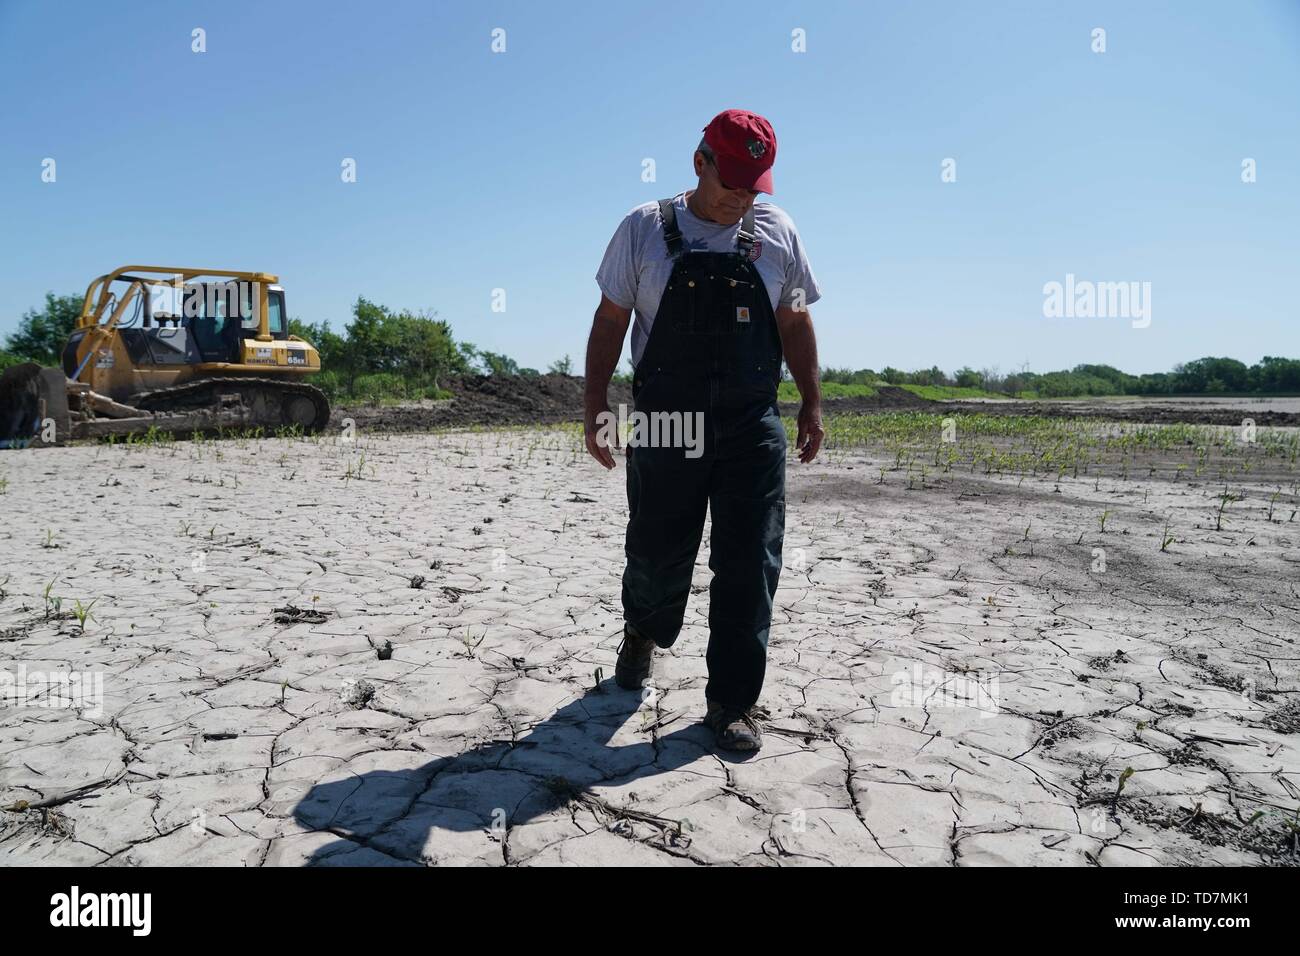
[{"x1": 294, "y1": 680, "x2": 728, "y2": 866}]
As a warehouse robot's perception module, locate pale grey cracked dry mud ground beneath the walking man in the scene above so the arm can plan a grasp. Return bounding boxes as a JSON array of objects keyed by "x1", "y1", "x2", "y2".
[{"x1": 0, "y1": 432, "x2": 1300, "y2": 866}]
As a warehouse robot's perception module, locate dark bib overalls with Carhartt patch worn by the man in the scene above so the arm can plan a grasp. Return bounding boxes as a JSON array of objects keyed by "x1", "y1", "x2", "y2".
[{"x1": 623, "y1": 199, "x2": 787, "y2": 710}]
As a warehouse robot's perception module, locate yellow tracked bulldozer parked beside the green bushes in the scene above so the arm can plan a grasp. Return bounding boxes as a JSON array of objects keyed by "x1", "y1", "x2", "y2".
[{"x1": 0, "y1": 265, "x2": 330, "y2": 445}]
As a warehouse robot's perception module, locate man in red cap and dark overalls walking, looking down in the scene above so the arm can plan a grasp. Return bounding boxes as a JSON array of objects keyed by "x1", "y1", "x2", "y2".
[{"x1": 585, "y1": 109, "x2": 824, "y2": 750}]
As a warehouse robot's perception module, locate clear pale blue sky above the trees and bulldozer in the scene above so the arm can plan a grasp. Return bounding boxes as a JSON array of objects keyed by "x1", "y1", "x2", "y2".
[{"x1": 0, "y1": 0, "x2": 1300, "y2": 372}]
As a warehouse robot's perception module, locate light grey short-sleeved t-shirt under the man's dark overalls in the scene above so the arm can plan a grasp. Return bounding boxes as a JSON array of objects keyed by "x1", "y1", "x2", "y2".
[{"x1": 595, "y1": 191, "x2": 822, "y2": 363}]
